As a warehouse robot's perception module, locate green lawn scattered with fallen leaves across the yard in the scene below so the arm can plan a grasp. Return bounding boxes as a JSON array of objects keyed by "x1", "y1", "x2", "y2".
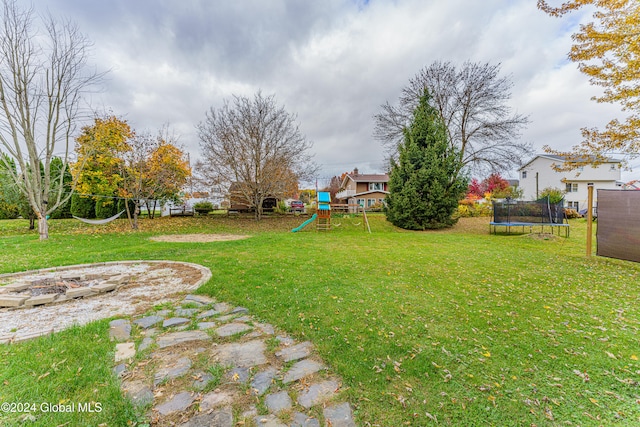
[{"x1": 0, "y1": 215, "x2": 640, "y2": 426}]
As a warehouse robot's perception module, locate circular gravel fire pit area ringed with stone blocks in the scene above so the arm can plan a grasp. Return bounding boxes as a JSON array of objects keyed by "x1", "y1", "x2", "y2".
[{"x1": 0, "y1": 261, "x2": 211, "y2": 343}]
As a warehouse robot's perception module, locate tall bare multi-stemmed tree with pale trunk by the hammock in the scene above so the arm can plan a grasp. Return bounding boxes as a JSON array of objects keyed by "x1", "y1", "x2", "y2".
[{"x1": 0, "y1": 0, "x2": 100, "y2": 240}]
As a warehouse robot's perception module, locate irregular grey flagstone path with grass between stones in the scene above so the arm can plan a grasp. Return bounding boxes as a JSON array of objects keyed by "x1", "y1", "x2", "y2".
[{"x1": 110, "y1": 295, "x2": 356, "y2": 427}]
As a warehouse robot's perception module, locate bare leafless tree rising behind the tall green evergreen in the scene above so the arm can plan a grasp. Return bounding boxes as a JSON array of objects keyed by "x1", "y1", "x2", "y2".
[{"x1": 374, "y1": 61, "x2": 532, "y2": 173}]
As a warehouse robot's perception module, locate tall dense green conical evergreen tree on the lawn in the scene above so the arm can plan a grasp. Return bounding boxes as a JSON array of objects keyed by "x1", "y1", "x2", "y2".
[{"x1": 386, "y1": 93, "x2": 468, "y2": 230}]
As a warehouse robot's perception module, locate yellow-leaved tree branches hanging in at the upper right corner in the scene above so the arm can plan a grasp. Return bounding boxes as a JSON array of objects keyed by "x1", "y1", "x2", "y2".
[{"x1": 538, "y1": 0, "x2": 640, "y2": 168}]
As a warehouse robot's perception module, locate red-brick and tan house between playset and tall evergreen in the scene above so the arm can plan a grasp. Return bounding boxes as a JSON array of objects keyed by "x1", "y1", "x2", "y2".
[{"x1": 335, "y1": 168, "x2": 389, "y2": 212}]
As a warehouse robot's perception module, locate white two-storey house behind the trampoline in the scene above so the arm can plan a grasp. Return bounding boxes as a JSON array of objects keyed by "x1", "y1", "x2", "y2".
[{"x1": 518, "y1": 154, "x2": 622, "y2": 211}]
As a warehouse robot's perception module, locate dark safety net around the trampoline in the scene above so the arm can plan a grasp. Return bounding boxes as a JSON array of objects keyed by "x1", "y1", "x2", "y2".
[{"x1": 493, "y1": 197, "x2": 565, "y2": 224}]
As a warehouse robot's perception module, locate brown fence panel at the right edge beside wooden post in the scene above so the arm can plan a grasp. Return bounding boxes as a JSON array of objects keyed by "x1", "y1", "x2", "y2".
[{"x1": 596, "y1": 190, "x2": 640, "y2": 262}]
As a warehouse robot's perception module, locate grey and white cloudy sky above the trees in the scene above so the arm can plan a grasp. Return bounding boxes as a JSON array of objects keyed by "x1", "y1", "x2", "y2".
[{"x1": 32, "y1": 0, "x2": 632, "y2": 181}]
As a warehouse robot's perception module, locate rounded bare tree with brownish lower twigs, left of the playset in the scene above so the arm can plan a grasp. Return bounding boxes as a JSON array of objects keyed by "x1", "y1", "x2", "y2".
[{"x1": 197, "y1": 92, "x2": 316, "y2": 220}]
